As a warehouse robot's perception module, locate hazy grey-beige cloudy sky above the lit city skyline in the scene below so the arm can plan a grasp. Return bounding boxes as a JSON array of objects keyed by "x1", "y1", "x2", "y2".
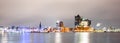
[{"x1": 0, "y1": 0, "x2": 120, "y2": 28}]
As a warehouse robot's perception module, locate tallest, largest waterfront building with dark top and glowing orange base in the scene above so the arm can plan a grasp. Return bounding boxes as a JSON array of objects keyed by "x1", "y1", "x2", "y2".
[{"x1": 74, "y1": 15, "x2": 92, "y2": 32}]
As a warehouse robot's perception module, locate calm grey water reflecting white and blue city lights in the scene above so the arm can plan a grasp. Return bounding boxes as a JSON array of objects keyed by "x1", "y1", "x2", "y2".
[{"x1": 0, "y1": 32, "x2": 120, "y2": 43}]
